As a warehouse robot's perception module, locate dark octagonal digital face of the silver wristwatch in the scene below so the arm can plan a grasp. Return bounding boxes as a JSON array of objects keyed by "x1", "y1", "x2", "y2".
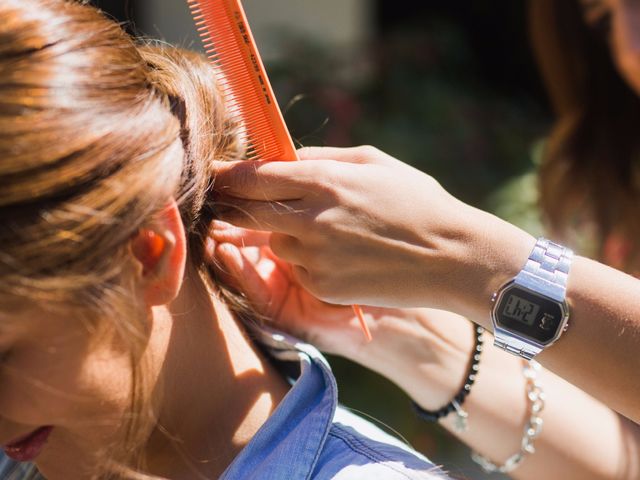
[{"x1": 494, "y1": 285, "x2": 564, "y2": 344}]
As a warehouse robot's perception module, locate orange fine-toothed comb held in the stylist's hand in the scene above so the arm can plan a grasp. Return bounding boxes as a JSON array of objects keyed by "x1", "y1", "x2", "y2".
[{"x1": 187, "y1": 0, "x2": 371, "y2": 341}]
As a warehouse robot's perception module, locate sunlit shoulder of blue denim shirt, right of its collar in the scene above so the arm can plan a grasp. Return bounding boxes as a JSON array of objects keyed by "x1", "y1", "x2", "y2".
[{"x1": 311, "y1": 407, "x2": 448, "y2": 480}]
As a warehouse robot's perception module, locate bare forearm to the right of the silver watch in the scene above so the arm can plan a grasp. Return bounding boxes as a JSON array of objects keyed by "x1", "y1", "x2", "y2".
[{"x1": 539, "y1": 257, "x2": 640, "y2": 424}]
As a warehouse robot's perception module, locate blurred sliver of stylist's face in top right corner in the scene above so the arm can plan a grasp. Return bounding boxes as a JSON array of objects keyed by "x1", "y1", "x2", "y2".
[{"x1": 580, "y1": 0, "x2": 640, "y2": 96}]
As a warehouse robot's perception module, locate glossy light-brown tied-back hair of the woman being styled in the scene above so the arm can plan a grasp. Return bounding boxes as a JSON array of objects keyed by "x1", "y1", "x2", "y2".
[{"x1": 0, "y1": 0, "x2": 250, "y2": 478}]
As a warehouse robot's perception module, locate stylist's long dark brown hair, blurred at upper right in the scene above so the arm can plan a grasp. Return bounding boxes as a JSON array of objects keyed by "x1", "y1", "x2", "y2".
[{"x1": 530, "y1": 0, "x2": 640, "y2": 267}]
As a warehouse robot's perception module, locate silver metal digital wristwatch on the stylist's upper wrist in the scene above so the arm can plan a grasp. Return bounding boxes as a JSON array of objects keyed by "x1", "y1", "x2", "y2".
[{"x1": 491, "y1": 238, "x2": 573, "y2": 360}]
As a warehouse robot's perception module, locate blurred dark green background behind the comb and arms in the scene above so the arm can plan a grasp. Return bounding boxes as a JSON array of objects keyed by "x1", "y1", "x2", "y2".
[{"x1": 95, "y1": 0, "x2": 551, "y2": 478}]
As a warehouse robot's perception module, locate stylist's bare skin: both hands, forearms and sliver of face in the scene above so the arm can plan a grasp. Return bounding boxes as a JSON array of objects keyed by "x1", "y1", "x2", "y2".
[{"x1": 210, "y1": 0, "x2": 640, "y2": 480}]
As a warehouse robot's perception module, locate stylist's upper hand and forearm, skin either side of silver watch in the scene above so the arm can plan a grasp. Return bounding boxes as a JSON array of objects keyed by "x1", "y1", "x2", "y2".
[{"x1": 216, "y1": 147, "x2": 640, "y2": 423}]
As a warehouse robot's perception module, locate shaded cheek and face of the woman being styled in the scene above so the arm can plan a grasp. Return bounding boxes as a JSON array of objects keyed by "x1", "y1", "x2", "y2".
[{"x1": 0, "y1": 309, "x2": 155, "y2": 478}]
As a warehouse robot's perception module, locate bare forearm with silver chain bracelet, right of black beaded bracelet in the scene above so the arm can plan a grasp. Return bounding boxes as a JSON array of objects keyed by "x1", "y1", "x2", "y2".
[{"x1": 442, "y1": 335, "x2": 640, "y2": 480}]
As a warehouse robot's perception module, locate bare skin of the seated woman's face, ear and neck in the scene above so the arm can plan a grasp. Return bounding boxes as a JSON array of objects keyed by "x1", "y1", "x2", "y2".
[{"x1": 0, "y1": 204, "x2": 287, "y2": 480}]
